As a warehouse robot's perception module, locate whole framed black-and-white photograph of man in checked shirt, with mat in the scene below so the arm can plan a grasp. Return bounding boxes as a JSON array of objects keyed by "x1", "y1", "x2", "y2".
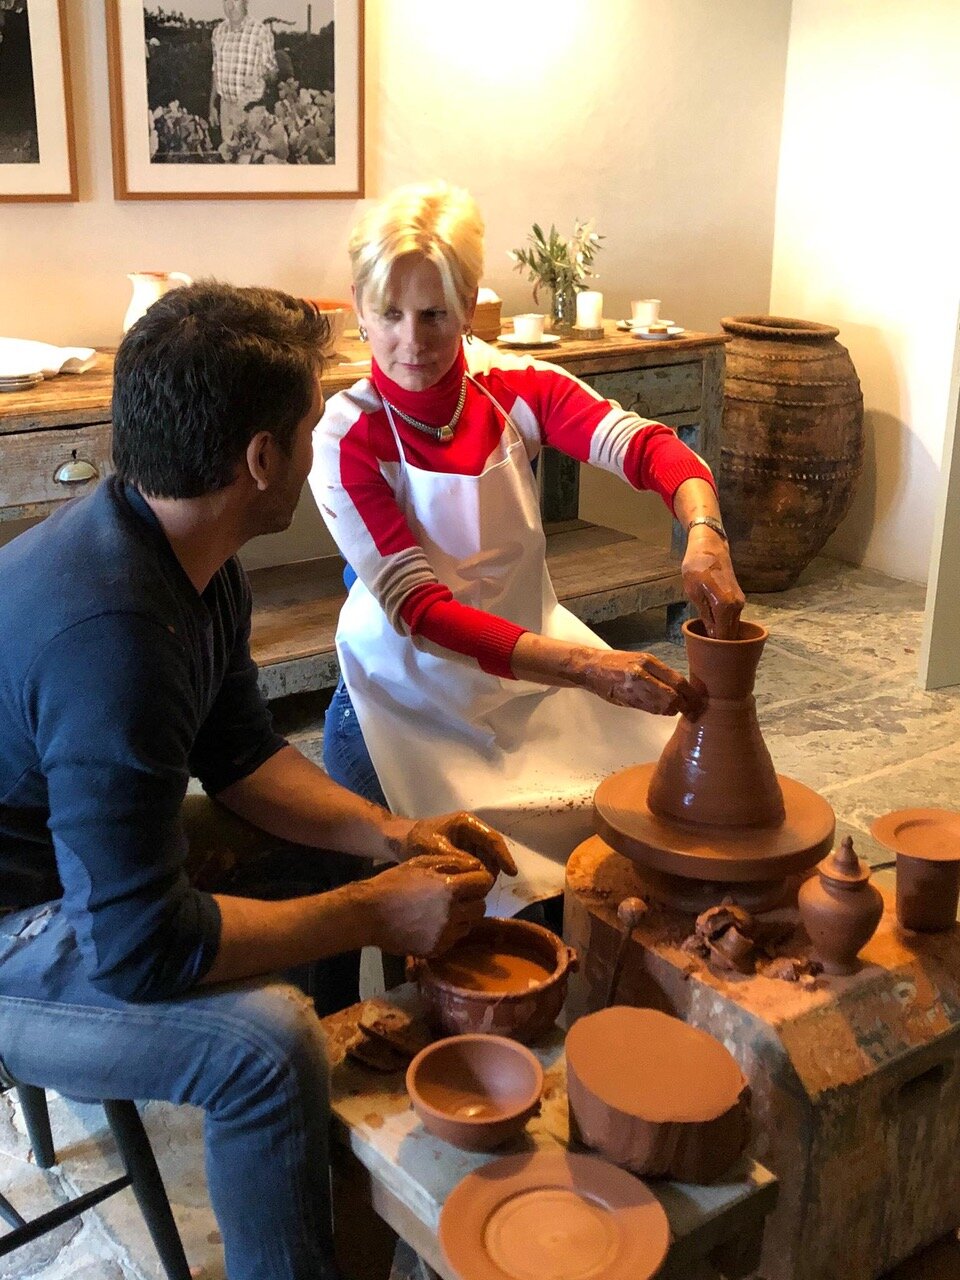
[{"x1": 106, "y1": 0, "x2": 364, "y2": 200}]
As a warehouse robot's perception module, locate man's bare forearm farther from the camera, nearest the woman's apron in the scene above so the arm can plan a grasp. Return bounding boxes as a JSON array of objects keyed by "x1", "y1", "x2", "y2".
[{"x1": 216, "y1": 746, "x2": 411, "y2": 861}]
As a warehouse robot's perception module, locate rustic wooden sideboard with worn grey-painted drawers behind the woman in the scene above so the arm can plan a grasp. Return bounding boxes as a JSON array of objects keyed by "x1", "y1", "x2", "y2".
[{"x1": 0, "y1": 323, "x2": 724, "y2": 698}]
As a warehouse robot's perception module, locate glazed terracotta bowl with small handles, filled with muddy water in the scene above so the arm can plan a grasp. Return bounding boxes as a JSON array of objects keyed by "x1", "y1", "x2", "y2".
[{"x1": 407, "y1": 916, "x2": 576, "y2": 1043}]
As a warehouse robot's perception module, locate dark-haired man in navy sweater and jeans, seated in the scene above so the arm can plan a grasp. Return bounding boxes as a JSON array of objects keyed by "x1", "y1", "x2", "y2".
[{"x1": 0, "y1": 283, "x2": 511, "y2": 1280}]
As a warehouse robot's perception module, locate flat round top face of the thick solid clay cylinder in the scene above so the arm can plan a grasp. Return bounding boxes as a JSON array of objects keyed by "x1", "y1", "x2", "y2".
[{"x1": 566, "y1": 1005, "x2": 746, "y2": 1124}]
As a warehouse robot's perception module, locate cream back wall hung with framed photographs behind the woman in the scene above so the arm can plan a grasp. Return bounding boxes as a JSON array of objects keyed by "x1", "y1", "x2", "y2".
[{"x1": 0, "y1": 0, "x2": 790, "y2": 563}]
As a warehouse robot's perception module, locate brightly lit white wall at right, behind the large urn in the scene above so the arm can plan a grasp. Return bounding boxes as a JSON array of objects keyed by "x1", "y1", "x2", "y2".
[{"x1": 769, "y1": 0, "x2": 960, "y2": 581}]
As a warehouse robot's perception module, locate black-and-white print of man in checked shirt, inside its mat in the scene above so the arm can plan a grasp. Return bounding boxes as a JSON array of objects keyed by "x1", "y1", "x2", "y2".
[{"x1": 142, "y1": 0, "x2": 337, "y2": 165}]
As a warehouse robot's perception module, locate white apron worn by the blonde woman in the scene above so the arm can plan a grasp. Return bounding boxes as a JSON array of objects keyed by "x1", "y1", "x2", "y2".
[{"x1": 337, "y1": 378, "x2": 675, "y2": 915}]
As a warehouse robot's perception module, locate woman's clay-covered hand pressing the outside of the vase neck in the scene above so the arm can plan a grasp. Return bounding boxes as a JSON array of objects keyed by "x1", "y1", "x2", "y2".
[{"x1": 568, "y1": 649, "x2": 703, "y2": 731}]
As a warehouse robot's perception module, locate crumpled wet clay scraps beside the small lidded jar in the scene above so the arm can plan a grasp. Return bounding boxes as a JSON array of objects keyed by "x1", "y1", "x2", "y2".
[{"x1": 680, "y1": 897, "x2": 823, "y2": 986}]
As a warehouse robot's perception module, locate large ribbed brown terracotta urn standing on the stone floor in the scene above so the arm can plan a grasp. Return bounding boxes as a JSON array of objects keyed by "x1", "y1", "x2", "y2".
[{"x1": 717, "y1": 316, "x2": 863, "y2": 591}]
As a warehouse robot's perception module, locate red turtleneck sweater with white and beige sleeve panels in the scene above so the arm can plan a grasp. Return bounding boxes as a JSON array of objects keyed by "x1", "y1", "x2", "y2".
[{"x1": 310, "y1": 342, "x2": 713, "y2": 677}]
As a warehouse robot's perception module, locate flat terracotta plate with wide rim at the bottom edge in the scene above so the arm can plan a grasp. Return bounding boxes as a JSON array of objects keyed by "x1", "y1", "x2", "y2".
[{"x1": 439, "y1": 1151, "x2": 669, "y2": 1280}]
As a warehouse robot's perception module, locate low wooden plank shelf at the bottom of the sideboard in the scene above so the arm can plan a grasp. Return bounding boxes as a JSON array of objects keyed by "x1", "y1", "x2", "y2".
[{"x1": 250, "y1": 521, "x2": 682, "y2": 698}]
